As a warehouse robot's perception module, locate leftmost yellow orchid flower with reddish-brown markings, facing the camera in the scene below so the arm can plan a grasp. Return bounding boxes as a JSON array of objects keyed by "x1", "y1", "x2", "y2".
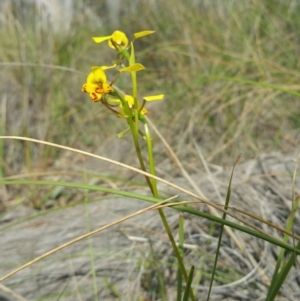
[{"x1": 81, "y1": 66, "x2": 114, "y2": 102}]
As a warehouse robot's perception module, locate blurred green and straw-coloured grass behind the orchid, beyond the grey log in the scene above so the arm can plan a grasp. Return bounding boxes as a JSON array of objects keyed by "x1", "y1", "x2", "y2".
[{"x1": 0, "y1": 0, "x2": 300, "y2": 298}]
